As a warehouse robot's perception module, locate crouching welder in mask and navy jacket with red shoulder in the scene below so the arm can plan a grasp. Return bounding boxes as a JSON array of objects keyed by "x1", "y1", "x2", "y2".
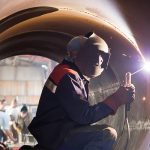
[{"x1": 29, "y1": 33, "x2": 134, "y2": 150}]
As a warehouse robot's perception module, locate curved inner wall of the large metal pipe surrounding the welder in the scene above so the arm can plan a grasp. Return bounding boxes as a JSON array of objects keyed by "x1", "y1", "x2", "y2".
[{"x1": 0, "y1": 6, "x2": 149, "y2": 150}]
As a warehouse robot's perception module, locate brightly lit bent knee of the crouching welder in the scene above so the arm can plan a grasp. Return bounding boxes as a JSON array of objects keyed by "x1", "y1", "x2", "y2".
[{"x1": 103, "y1": 127, "x2": 117, "y2": 141}]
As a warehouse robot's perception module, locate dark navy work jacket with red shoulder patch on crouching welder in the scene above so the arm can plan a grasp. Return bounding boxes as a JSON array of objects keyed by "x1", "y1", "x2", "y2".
[{"x1": 29, "y1": 60, "x2": 112, "y2": 150}]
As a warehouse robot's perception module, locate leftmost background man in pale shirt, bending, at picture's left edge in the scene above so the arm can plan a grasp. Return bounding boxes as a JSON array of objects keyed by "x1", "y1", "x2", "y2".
[{"x1": 0, "y1": 99, "x2": 16, "y2": 142}]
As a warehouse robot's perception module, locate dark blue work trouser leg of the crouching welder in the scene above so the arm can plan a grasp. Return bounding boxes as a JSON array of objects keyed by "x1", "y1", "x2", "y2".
[{"x1": 58, "y1": 125, "x2": 117, "y2": 150}]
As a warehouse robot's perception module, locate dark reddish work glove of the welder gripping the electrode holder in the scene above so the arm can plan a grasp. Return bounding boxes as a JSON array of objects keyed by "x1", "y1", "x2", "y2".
[{"x1": 103, "y1": 84, "x2": 135, "y2": 113}]
